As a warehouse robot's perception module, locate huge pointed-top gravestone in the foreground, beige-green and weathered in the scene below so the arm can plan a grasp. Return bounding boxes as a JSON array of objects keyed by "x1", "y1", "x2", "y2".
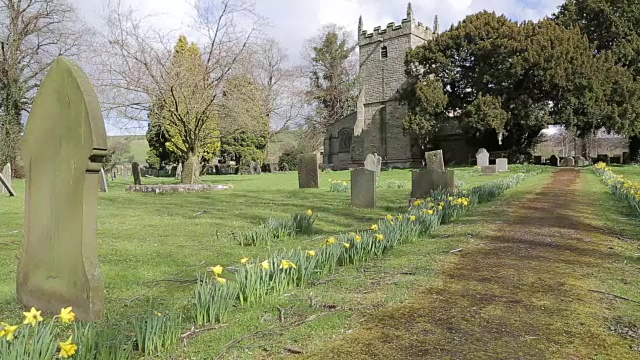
[{"x1": 17, "y1": 57, "x2": 107, "y2": 321}]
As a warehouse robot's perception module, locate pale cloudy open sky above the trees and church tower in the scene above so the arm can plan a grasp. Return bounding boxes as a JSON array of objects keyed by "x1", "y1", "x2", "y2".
[{"x1": 70, "y1": 0, "x2": 563, "y2": 135}]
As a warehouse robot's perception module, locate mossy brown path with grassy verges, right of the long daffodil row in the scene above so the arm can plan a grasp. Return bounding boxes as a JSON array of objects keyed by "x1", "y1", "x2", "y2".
[{"x1": 276, "y1": 168, "x2": 640, "y2": 359}]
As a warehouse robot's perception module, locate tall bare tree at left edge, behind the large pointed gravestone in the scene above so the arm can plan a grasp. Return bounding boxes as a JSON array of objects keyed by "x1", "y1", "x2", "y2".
[{"x1": 0, "y1": 0, "x2": 92, "y2": 169}]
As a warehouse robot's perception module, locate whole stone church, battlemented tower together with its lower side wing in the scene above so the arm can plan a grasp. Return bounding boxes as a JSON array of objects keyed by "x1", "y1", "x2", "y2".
[{"x1": 323, "y1": 3, "x2": 472, "y2": 170}]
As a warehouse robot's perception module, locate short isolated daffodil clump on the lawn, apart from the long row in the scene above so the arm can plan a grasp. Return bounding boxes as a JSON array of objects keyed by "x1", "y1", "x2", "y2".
[{"x1": 237, "y1": 209, "x2": 315, "y2": 246}]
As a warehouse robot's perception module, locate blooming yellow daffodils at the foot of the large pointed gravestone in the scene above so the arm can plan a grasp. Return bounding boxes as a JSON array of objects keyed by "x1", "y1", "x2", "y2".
[{"x1": 0, "y1": 307, "x2": 78, "y2": 360}]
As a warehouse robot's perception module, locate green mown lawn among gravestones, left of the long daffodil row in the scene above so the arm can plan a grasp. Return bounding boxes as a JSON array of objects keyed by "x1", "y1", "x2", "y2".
[{"x1": 0, "y1": 166, "x2": 518, "y2": 358}]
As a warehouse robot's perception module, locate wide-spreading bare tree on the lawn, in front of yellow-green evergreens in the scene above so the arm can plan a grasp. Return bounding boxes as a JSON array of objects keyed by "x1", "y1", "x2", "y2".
[{"x1": 95, "y1": 0, "x2": 262, "y2": 182}]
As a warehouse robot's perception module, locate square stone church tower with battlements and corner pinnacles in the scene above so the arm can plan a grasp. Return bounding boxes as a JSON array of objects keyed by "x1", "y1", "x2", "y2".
[{"x1": 351, "y1": 3, "x2": 434, "y2": 168}]
